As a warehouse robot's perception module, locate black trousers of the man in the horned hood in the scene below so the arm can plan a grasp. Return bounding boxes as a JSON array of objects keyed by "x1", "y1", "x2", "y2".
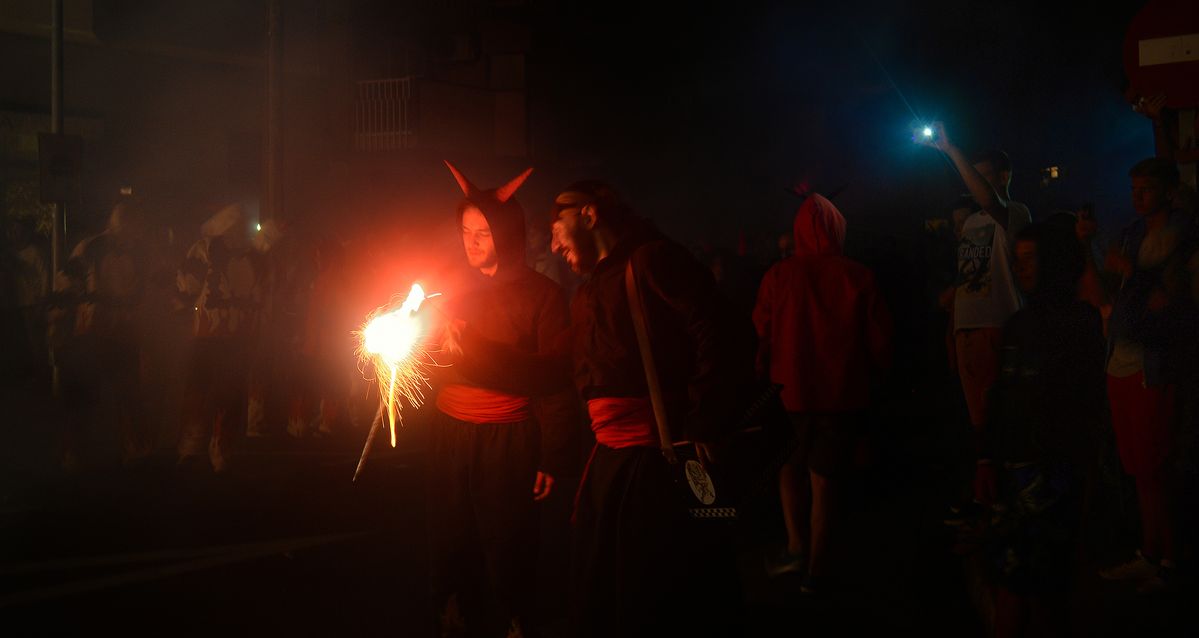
[{"x1": 428, "y1": 413, "x2": 541, "y2": 636}]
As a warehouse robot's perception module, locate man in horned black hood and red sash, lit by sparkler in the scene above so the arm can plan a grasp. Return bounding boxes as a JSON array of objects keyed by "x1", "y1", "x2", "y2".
[{"x1": 429, "y1": 162, "x2": 577, "y2": 637}]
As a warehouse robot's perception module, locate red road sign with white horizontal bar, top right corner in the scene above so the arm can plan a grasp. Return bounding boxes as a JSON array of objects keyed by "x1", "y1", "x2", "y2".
[{"x1": 1123, "y1": 0, "x2": 1199, "y2": 109}]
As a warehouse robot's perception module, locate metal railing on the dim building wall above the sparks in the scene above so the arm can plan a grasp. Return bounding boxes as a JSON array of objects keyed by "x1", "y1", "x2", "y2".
[{"x1": 354, "y1": 77, "x2": 416, "y2": 151}]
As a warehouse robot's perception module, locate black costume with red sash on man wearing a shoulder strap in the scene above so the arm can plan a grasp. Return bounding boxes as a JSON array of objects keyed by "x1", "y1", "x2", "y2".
[{"x1": 571, "y1": 222, "x2": 753, "y2": 636}]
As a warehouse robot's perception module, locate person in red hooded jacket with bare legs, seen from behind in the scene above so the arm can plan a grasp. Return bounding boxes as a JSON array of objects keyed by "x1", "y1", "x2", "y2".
[{"x1": 753, "y1": 193, "x2": 891, "y2": 592}]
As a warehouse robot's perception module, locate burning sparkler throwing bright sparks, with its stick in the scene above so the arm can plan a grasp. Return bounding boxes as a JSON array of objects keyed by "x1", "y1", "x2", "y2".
[{"x1": 354, "y1": 284, "x2": 436, "y2": 481}]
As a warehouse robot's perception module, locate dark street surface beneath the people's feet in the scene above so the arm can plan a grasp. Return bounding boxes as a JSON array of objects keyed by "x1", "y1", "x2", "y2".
[{"x1": 0, "y1": 376, "x2": 1199, "y2": 637}]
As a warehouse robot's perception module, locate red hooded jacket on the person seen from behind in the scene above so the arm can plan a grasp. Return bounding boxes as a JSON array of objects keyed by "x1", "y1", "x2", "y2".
[{"x1": 753, "y1": 194, "x2": 891, "y2": 413}]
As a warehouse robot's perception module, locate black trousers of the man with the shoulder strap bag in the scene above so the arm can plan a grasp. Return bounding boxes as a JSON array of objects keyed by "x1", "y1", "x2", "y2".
[{"x1": 572, "y1": 445, "x2": 743, "y2": 637}]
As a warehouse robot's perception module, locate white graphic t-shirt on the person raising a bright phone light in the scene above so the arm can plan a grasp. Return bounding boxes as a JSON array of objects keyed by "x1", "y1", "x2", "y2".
[{"x1": 953, "y1": 201, "x2": 1032, "y2": 330}]
